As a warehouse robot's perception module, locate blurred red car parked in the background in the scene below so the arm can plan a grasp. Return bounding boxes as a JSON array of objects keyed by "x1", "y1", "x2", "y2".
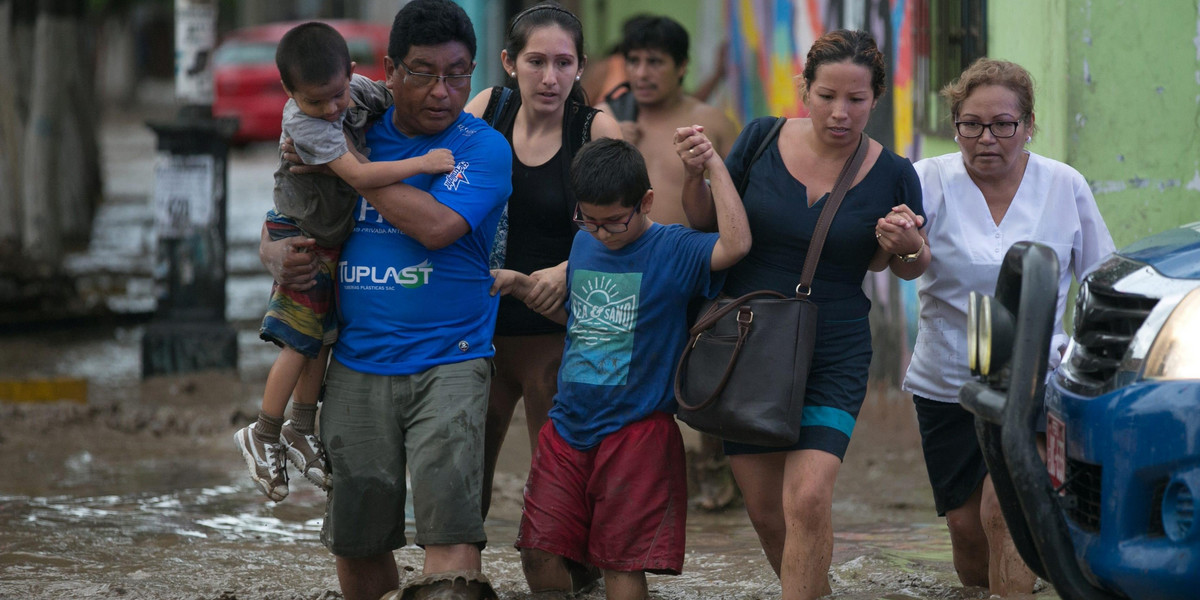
[{"x1": 212, "y1": 20, "x2": 391, "y2": 144}]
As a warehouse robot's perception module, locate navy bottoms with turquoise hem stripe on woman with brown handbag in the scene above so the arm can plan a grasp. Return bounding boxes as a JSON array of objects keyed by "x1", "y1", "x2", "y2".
[{"x1": 725, "y1": 317, "x2": 871, "y2": 460}]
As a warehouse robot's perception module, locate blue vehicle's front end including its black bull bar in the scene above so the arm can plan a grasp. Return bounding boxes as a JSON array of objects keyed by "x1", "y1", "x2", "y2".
[{"x1": 960, "y1": 223, "x2": 1200, "y2": 600}]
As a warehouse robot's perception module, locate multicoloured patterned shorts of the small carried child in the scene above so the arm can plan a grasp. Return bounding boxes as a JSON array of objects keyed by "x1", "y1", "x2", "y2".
[{"x1": 258, "y1": 210, "x2": 341, "y2": 359}]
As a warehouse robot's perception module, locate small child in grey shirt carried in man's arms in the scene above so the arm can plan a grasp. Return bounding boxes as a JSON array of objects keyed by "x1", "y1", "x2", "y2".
[{"x1": 234, "y1": 22, "x2": 454, "y2": 502}]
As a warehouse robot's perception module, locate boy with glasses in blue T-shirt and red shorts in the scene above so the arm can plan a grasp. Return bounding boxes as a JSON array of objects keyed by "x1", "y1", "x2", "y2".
[{"x1": 493, "y1": 134, "x2": 750, "y2": 599}]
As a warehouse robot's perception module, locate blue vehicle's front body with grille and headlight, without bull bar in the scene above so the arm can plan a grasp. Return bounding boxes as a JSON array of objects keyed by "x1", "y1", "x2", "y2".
[{"x1": 1045, "y1": 226, "x2": 1200, "y2": 600}]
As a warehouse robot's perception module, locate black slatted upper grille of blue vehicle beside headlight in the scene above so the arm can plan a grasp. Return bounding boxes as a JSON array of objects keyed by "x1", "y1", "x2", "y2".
[{"x1": 1066, "y1": 278, "x2": 1158, "y2": 394}]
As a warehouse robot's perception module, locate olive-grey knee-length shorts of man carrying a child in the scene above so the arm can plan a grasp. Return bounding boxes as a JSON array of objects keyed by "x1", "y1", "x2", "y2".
[{"x1": 320, "y1": 359, "x2": 491, "y2": 558}]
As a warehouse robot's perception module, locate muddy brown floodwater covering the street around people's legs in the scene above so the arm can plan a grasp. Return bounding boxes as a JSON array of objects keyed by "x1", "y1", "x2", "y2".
[{"x1": 0, "y1": 325, "x2": 1055, "y2": 600}]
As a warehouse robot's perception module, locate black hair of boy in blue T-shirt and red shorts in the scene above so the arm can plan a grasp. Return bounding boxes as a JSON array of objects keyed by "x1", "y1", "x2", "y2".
[{"x1": 571, "y1": 138, "x2": 650, "y2": 208}]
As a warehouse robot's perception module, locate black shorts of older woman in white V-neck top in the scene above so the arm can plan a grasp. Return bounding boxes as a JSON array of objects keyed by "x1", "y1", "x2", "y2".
[{"x1": 912, "y1": 396, "x2": 988, "y2": 517}]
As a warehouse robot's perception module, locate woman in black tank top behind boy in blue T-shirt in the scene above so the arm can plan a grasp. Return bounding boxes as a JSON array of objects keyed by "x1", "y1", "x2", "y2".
[{"x1": 466, "y1": 2, "x2": 620, "y2": 516}]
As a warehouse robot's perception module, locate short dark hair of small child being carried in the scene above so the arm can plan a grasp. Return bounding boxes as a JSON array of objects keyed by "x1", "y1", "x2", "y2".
[{"x1": 275, "y1": 20, "x2": 350, "y2": 91}]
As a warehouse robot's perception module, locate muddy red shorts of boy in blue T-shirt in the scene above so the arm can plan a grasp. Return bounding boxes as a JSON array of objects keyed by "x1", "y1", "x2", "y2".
[{"x1": 516, "y1": 413, "x2": 688, "y2": 575}]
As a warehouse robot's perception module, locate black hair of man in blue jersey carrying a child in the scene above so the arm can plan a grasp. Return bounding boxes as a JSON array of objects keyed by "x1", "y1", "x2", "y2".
[{"x1": 388, "y1": 0, "x2": 475, "y2": 66}]
